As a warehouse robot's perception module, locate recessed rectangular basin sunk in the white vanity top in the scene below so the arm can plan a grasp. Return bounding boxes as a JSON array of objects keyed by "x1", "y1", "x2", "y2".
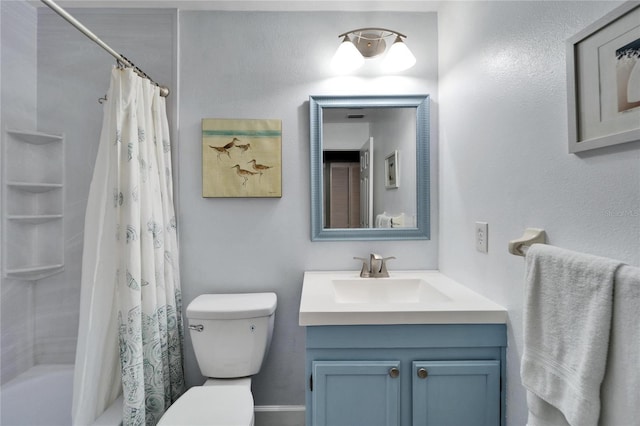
[{"x1": 331, "y1": 278, "x2": 451, "y2": 304}]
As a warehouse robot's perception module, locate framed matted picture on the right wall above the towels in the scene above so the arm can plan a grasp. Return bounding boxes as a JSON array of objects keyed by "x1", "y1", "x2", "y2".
[{"x1": 567, "y1": 1, "x2": 640, "y2": 153}]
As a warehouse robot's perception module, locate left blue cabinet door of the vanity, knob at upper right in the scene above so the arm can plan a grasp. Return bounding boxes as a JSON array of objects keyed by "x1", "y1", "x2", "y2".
[{"x1": 312, "y1": 361, "x2": 400, "y2": 426}]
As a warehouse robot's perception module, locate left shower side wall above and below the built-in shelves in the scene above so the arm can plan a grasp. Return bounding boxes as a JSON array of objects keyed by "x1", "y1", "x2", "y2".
[{"x1": 0, "y1": 1, "x2": 37, "y2": 383}]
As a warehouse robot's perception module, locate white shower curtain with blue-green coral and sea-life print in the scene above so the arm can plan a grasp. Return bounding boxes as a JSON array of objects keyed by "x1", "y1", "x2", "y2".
[{"x1": 72, "y1": 67, "x2": 184, "y2": 425}]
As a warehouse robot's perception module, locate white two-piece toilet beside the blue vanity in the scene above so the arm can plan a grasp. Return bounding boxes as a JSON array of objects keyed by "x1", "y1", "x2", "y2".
[{"x1": 158, "y1": 293, "x2": 277, "y2": 426}]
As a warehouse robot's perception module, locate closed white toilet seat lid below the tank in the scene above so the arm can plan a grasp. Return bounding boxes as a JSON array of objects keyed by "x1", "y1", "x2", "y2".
[{"x1": 158, "y1": 386, "x2": 253, "y2": 426}]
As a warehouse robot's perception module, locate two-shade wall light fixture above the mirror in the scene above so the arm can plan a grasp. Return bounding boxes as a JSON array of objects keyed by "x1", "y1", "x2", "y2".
[{"x1": 331, "y1": 28, "x2": 416, "y2": 73}]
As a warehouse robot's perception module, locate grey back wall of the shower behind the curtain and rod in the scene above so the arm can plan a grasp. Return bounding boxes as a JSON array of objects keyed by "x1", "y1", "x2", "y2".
[{"x1": 33, "y1": 8, "x2": 176, "y2": 363}]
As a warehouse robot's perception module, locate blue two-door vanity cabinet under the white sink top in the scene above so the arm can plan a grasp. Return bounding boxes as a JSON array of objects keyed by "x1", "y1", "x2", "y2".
[{"x1": 306, "y1": 324, "x2": 507, "y2": 426}]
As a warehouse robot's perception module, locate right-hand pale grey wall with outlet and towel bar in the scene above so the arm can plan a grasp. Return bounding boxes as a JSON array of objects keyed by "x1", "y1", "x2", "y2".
[{"x1": 438, "y1": 1, "x2": 640, "y2": 425}]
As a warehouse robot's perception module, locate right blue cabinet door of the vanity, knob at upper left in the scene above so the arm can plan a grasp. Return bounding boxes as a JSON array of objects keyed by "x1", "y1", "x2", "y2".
[{"x1": 412, "y1": 361, "x2": 500, "y2": 426}]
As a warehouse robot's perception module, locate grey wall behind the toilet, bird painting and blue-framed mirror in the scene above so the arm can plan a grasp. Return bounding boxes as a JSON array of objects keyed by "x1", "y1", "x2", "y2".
[{"x1": 178, "y1": 11, "x2": 438, "y2": 405}]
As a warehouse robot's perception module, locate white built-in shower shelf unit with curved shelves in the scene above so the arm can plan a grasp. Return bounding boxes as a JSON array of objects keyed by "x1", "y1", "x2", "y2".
[{"x1": 2, "y1": 129, "x2": 64, "y2": 280}]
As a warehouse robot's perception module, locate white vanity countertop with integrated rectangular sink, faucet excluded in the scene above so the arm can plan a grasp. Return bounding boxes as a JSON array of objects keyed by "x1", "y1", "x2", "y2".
[{"x1": 299, "y1": 271, "x2": 507, "y2": 326}]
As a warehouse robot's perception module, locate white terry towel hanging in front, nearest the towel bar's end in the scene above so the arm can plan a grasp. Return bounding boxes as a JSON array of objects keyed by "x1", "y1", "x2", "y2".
[{"x1": 520, "y1": 244, "x2": 621, "y2": 426}]
